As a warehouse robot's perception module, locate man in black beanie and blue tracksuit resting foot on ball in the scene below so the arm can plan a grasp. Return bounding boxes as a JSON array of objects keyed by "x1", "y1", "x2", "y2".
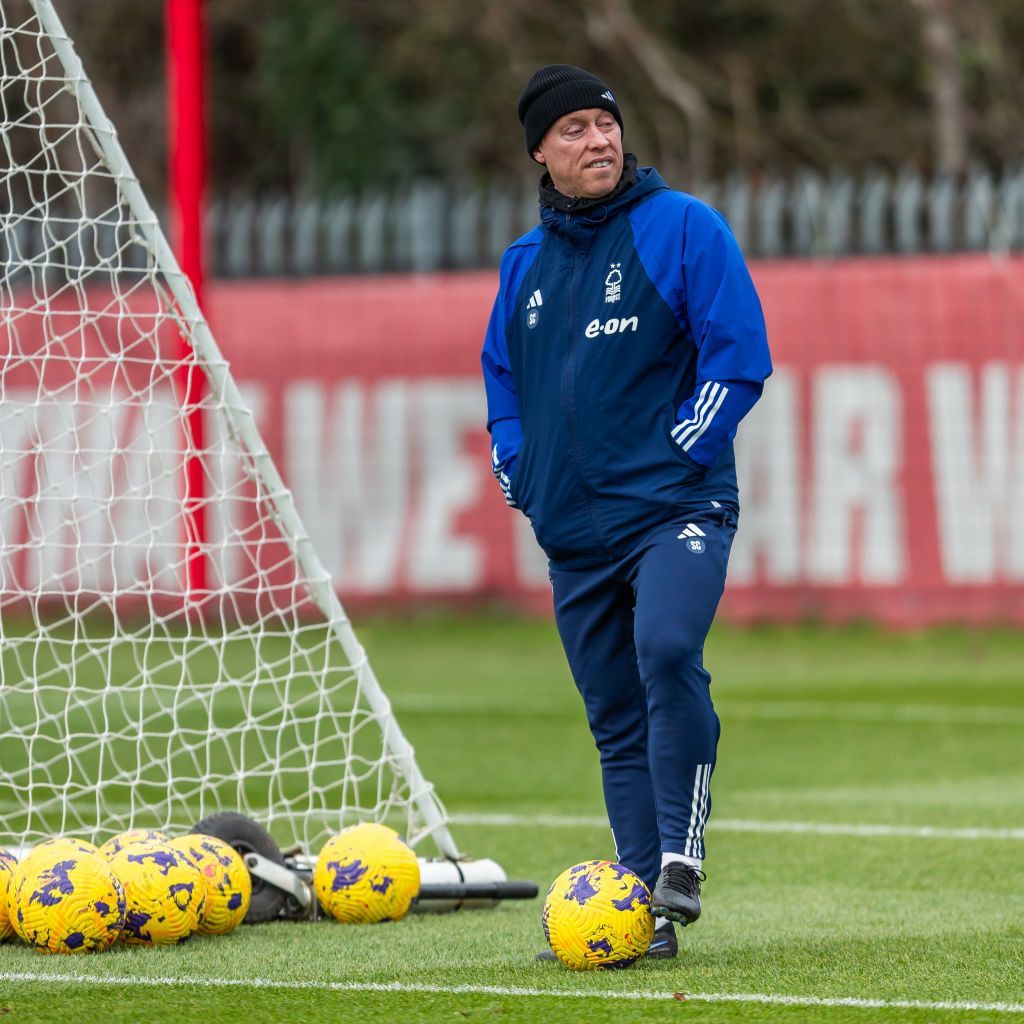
[{"x1": 482, "y1": 65, "x2": 771, "y2": 956}]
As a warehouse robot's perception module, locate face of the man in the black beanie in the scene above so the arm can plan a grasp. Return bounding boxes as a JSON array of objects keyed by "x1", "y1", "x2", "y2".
[{"x1": 534, "y1": 108, "x2": 623, "y2": 199}]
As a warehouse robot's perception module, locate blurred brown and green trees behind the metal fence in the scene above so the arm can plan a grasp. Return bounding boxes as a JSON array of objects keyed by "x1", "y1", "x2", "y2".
[{"x1": 54, "y1": 0, "x2": 1024, "y2": 201}]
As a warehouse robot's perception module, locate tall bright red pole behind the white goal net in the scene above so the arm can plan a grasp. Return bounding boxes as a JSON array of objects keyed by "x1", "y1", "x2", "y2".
[{"x1": 165, "y1": 0, "x2": 207, "y2": 600}]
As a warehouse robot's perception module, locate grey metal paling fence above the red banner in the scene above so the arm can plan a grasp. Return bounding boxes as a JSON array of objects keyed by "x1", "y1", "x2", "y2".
[{"x1": 209, "y1": 167, "x2": 1024, "y2": 278}]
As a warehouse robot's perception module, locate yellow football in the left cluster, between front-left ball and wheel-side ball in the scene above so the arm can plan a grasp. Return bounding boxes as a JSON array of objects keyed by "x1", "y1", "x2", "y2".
[{"x1": 110, "y1": 841, "x2": 206, "y2": 946}]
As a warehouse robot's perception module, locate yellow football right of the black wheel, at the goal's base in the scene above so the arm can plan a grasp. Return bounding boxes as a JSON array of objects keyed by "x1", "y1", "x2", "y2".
[{"x1": 313, "y1": 822, "x2": 420, "y2": 924}]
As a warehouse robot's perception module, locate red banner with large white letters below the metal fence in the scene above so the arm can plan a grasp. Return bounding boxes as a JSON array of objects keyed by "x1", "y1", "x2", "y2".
[{"x1": 0, "y1": 256, "x2": 1024, "y2": 625}]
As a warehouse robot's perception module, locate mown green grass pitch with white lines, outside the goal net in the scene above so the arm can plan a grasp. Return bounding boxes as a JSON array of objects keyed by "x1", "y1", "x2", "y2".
[{"x1": 0, "y1": 615, "x2": 1024, "y2": 1024}]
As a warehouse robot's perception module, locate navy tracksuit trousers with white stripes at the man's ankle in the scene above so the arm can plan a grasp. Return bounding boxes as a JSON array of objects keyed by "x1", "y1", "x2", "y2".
[{"x1": 551, "y1": 506, "x2": 736, "y2": 887}]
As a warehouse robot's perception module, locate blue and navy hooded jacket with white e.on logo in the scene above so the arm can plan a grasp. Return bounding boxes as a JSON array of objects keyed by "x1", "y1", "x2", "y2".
[{"x1": 482, "y1": 168, "x2": 771, "y2": 568}]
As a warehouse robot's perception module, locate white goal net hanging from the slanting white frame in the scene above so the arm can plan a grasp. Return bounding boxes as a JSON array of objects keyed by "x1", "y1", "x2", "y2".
[{"x1": 0, "y1": 0, "x2": 458, "y2": 856}]
